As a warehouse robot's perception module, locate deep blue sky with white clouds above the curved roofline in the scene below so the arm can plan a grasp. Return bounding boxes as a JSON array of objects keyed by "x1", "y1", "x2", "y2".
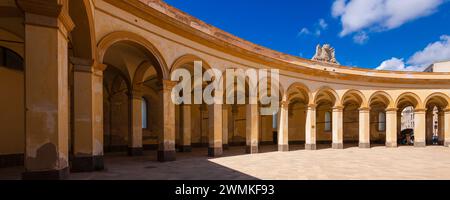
[{"x1": 166, "y1": 0, "x2": 450, "y2": 71}]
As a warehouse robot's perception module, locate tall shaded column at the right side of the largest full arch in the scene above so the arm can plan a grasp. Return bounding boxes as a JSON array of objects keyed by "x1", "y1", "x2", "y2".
[{"x1": 158, "y1": 80, "x2": 176, "y2": 162}]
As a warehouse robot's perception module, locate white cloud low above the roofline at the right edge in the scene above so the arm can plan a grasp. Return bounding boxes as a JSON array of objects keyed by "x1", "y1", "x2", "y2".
[{"x1": 377, "y1": 35, "x2": 450, "y2": 71}]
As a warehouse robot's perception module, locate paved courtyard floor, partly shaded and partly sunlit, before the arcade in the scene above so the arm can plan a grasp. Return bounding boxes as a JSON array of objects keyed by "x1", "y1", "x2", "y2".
[{"x1": 0, "y1": 146, "x2": 450, "y2": 180}]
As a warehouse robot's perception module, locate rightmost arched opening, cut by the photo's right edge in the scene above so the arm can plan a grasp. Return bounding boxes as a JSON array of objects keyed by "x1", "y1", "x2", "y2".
[{"x1": 425, "y1": 93, "x2": 449, "y2": 145}]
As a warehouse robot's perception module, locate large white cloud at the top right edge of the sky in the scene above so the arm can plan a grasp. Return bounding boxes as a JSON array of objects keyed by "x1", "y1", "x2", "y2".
[{"x1": 332, "y1": 0, "x2": 444, "y2": 36}]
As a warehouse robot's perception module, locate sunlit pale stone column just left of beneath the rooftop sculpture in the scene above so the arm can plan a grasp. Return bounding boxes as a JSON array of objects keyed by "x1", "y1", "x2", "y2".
[{"x1": 305, "y1": 104, "x2": 317, "y2": 150}]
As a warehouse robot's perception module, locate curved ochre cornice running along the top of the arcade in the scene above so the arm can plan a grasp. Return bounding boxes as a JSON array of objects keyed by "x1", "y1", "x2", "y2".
[{"x1": 101, "y1": 0, "x2": 450, "y2": 85}]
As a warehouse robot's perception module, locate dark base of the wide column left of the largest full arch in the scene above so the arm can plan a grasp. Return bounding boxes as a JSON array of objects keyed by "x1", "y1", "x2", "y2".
[{"x1": 70, "y1": 156, "x2": 105, "y2": 172}]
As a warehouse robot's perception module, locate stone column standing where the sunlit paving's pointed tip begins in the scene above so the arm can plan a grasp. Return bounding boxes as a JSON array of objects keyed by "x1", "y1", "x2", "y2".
[{"x1": 208, "y1": 104, "x2": 223, "y2": 157}]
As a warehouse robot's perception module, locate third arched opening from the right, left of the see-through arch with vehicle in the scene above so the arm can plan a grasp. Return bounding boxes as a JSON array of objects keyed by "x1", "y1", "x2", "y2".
[{"x1": 369, "y1": 92, "x2": 391, "y2": 147}]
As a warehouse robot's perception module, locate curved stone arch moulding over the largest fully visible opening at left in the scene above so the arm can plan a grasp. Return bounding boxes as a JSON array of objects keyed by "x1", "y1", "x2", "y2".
[{"x1": 97, "y1": 31, "x2": 170, "y2": 80}]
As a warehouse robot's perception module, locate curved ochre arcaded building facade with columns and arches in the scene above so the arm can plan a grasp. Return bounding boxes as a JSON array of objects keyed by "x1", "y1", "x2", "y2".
[{"x1": 0, "y1": 0, "x2": 450, "y2": 179}]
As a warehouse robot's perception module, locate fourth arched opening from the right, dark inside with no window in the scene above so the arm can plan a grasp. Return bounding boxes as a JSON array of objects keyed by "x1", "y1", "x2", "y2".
[{"x1": 342, "y1": 90, "x2": 365, "y2": 147}]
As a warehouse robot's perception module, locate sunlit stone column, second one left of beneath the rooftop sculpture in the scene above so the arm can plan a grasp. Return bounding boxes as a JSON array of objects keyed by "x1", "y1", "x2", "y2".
[{"x1": 278, "y1": 101, "x2": 289, "y2": 151}]
